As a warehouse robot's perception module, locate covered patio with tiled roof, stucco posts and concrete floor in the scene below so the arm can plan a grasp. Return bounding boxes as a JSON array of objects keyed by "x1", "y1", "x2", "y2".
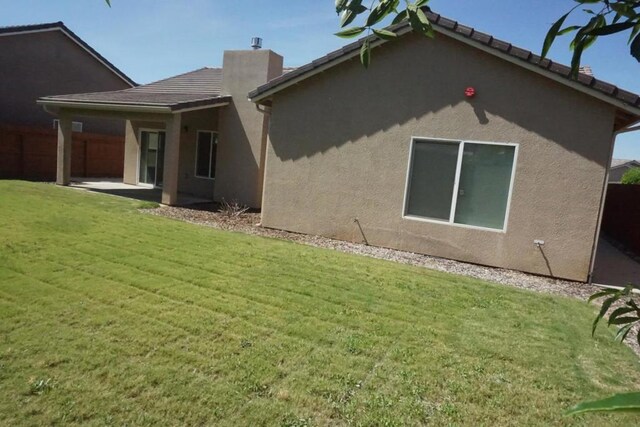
[{"x1": 38, "y1": 68, "x2": 231, "y2": 205}]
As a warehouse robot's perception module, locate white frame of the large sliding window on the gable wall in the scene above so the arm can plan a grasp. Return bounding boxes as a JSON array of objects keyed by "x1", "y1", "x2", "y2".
[{"x1": 402, "y1": 136, "x2": 520, "y2": 233}]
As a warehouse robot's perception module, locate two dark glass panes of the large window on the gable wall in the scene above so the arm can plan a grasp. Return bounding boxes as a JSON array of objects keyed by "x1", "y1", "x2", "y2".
[{"x1": 405, "y1": 140, "x2": 516, "y2": 230}]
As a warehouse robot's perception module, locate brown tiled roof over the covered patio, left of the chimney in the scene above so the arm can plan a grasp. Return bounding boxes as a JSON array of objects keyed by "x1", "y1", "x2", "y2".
[{"x1": 38, "y1": 67, "x2": 231, "y2": 111}]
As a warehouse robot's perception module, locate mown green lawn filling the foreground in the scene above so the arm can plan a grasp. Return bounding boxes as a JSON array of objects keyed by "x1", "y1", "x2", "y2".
[{"x1": 0, "y1": 181, "x2": 640, "y2": 426}]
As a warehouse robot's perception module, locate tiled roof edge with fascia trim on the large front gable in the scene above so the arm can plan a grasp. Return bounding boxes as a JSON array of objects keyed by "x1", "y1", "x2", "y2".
[{"x1": 249, "y1": 10, "x2": 640, "y2": 120}]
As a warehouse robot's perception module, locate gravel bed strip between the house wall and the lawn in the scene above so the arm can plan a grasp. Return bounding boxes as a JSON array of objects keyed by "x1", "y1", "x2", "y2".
[{"x1": 141, "y1": 203, "x2": 640, "y2": 356}]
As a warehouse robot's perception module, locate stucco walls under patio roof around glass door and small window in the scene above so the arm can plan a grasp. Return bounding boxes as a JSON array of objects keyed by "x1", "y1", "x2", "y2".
[{"x1": 124, "y1": 109, "x2": 220, "y2": 199}]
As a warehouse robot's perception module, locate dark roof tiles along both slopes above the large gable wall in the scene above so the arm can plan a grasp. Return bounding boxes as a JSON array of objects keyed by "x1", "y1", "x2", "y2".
[{"x1": 249, "y1": 9, "x2": 640, "y2": 115}]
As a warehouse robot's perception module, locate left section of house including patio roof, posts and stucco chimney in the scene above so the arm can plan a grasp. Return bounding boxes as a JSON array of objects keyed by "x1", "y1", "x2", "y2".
[{"x1": 38, "y1": 49, "x2": 285, "y2": 208}]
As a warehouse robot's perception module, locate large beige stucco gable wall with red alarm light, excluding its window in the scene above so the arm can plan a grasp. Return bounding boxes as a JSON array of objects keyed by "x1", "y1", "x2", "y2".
[{"x1": 262, "y1": 35, "x2": 614, "y2": 281}]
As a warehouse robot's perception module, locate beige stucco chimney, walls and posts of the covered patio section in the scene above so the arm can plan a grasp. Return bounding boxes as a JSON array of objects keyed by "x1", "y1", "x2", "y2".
[{"x1": 44, "y1": 50, "x2": 283, "y2": 208}]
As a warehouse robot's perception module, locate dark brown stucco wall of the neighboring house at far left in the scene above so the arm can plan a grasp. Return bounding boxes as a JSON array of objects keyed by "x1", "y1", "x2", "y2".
[{"x1": 0, "y1": 31, "x2": 131, "y2": 135}]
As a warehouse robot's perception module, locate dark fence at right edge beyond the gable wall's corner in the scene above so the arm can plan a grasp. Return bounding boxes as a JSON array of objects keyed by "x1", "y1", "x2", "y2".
[{"x1": 602, "y1": 184, "x2": 640, "y2": 255}]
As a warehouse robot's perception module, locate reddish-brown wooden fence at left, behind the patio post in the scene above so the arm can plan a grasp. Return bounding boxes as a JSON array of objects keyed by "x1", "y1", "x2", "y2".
[{"x1": 0, "y1": 125, "x2": 124, "y2": 181}]
